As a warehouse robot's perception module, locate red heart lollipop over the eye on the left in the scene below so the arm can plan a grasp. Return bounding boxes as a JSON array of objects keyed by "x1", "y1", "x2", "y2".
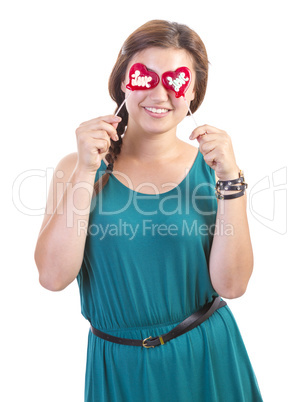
[{"x1": 126, "y1": 63, "x2": 159, "y2": 91}]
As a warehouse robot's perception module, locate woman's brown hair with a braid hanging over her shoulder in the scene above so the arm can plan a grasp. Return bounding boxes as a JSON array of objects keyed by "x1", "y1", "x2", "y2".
[{"x1": 94, "y1": 20, "x2": 208, "y2": 194}]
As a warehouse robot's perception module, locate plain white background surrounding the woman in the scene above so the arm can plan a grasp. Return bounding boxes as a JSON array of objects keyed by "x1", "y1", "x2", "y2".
[{"x1": 0, "y1": 0, "x2": 298, "y2": 402}]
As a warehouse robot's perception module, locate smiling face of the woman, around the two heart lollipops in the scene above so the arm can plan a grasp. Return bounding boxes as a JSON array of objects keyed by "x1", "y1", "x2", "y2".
[{"x1": 121, "y1": 47, "x2": 195, "y2": 137}]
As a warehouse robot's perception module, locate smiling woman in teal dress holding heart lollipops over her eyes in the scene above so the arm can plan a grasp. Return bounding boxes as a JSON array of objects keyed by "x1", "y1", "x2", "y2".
[{"x1": 35, "y1": 20, "x2": 262, "y2": 402}]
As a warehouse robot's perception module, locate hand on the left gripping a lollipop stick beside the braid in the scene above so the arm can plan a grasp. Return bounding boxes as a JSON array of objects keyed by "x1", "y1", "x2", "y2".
[{"x1": 76, "y1": 115, "x2": 121, "y2": 173}]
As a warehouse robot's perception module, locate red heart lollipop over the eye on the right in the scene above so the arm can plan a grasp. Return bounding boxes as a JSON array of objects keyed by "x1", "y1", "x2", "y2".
[{"x1": 162, "y1": 67, "x2": 191, "y2": 98}]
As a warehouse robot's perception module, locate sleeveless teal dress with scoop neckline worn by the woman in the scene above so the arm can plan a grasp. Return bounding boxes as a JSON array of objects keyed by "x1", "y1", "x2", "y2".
[{"x1": 77, "y1": 152, "x2": 262, "y2": 402}]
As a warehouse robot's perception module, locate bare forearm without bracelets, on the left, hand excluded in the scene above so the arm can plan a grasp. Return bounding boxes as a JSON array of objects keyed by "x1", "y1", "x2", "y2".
[{"x1": 35, "y1": 170, "x2": 94, "y2": 290}]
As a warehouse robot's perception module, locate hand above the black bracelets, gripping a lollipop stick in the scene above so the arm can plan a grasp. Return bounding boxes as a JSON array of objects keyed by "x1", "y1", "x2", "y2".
[{"x1": 190, "y1": 124, "x2": 239, "y2": 180}]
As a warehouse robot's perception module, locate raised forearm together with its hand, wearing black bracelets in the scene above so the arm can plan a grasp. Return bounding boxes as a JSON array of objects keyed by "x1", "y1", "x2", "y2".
[{"x1": 190, "y1": 124, "x2": 253, "y2": 298}]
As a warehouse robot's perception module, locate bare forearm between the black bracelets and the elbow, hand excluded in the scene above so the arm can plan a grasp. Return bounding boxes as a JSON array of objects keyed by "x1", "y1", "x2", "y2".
[{"x1": 209, "y1": 195, "x2": 253, "y2": 298}]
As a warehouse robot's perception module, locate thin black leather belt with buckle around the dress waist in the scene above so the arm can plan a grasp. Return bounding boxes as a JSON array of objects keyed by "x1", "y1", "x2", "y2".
[{"x1": 91, "y1": 297, "x2": 227, "y2": 348}]
